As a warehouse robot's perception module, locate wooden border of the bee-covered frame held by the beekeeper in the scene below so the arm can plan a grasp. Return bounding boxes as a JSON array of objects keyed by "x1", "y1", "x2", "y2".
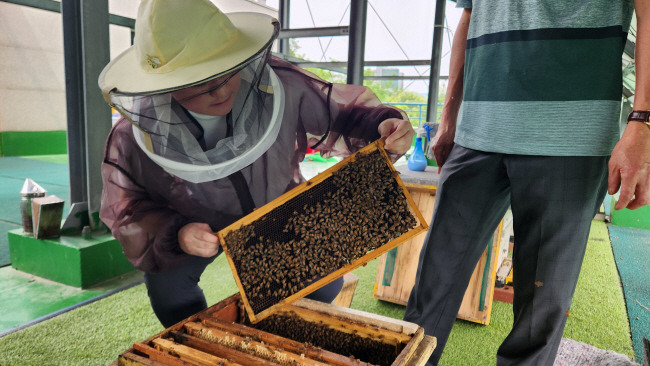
[{"x1": 218, "y1": 139, "x2": 428, "y2": 323}]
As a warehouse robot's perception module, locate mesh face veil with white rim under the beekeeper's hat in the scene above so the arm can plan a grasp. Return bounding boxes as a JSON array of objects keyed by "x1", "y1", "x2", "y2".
[{"x1": 109, "y1": 44, "x2": 284, "y2": 183}]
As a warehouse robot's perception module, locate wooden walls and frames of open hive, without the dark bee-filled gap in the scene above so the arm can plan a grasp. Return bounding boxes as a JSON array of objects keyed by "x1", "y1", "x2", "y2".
[{"x1": 115, "y1": 293, "x2": 436, "y2": 366}]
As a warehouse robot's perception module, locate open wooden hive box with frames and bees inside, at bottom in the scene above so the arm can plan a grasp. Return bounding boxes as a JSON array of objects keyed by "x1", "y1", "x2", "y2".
[{"x1": 117, "y1": 293, "x2": 436, "y2": 366}]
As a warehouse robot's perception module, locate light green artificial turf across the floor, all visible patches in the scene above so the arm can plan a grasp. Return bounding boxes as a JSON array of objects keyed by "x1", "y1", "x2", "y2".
[{"x1": 0, "y1": 221, "x2": 634, "y2": 366}]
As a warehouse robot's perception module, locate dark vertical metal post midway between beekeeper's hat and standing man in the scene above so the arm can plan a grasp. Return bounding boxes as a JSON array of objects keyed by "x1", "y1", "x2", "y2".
[{"x1": 347, "y1": 0, "x2": 368, "y2": 85}]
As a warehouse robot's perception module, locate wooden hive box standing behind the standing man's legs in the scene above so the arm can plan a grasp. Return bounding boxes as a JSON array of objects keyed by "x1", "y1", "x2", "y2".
[{"x1": 373, "y1": 183, "x2": 503, "y2": 325}]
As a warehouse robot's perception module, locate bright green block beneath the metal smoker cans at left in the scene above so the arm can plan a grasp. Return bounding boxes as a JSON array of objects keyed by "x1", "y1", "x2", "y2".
[{"x1": 8, "y1": 228, "x2": 135, "y2": 288}]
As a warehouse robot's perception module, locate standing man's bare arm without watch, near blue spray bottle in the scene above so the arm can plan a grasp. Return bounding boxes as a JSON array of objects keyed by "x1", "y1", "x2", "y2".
[{"x1": 431, "y1": 9, "x2": 472, "y2": 167}]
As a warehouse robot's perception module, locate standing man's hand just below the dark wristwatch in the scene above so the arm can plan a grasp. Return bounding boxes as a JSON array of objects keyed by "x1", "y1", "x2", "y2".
[{"x1": 608, "y1": 122, "x2": 650, "y2": 210}]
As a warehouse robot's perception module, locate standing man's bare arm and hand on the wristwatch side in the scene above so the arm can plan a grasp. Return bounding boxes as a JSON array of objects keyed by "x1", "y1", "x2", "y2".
[{"x1": 608, "y1": 0, "x2": 650, "y2": 210}]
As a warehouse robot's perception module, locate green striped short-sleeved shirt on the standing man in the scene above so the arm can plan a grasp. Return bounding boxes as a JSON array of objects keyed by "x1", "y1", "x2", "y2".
[{"x1": 455, "y1": 0, "x2": 634, "y2": 156}]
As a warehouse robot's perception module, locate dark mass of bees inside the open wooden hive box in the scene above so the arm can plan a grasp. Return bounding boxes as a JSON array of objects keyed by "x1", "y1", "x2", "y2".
[{"x1": 248, "y1": 313, "x2": 404, "y2": 366}]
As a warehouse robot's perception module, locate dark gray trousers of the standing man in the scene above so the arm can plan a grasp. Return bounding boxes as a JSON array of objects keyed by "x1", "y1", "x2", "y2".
[{"x1": 404, "y1": 145, "x2": 609, "y2": 365}]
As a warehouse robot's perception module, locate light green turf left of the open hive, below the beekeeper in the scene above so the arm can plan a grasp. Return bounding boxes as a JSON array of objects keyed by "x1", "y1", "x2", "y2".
[{"x1": 0, "y1": 256, "x2": 237, "y2": 366}]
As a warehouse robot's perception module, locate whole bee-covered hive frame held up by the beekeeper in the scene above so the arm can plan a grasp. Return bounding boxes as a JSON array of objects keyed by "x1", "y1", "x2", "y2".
[{"x1": 218, "y1": 140, "x2": 427, "y2": 323}]
